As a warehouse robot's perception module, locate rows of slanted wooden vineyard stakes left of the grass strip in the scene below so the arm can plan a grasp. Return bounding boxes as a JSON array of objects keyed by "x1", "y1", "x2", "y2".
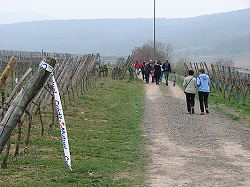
[{"x1": 0, "y1": 51, "x2": 100, "y2": 168}]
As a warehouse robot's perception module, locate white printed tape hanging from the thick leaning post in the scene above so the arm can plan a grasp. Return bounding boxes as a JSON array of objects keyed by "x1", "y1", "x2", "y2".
[{"x1": 39, "y1": 61, "x2": 72, "y2": 171}]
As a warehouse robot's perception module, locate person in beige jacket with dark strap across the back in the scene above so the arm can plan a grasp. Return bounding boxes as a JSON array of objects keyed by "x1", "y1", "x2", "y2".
[{"x1": 183, "y1": 70, "x2": 196, "y2": 114}]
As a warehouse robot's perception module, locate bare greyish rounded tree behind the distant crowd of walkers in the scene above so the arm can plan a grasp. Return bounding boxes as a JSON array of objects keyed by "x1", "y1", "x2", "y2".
[{"x1": 132, "y1": 42, "x2": 173, "y2": 61}]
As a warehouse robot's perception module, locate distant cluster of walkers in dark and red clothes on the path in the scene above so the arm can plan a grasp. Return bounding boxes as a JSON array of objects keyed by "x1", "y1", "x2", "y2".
[{"x1": 135, "y1": 60, "x2": 176, "y2": 86}]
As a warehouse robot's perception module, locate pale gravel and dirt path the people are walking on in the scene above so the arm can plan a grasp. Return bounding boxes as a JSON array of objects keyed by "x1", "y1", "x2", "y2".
[{"x1": 143, "y1": 84, "x2": 250, "y2": 187}]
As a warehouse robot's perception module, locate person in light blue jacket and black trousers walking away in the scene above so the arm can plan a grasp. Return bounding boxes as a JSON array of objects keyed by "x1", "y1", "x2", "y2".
[{"x1": 196, "y1": 69, "x2": 210, "y2": 115}]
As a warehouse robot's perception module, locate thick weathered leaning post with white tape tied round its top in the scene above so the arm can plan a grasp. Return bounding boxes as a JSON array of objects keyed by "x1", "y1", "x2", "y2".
[{"x1": 0, "y1": 58, "x2": 56, "y2": 153}]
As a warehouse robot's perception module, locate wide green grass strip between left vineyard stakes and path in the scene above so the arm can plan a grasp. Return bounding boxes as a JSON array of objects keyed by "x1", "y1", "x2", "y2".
[{"x1": 0, "y1": 79, "x2": 148, "y2": 186}]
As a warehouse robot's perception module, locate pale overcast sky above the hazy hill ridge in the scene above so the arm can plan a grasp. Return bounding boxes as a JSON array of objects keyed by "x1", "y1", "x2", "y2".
[{"x1": 0, "y1": 0, "x2": 250, "y2": 24}]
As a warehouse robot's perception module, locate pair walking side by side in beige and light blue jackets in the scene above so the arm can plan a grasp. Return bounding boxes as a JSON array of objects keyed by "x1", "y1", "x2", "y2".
[{"x1": 183, "y1": 69, "x2": 211, "y2": 115}]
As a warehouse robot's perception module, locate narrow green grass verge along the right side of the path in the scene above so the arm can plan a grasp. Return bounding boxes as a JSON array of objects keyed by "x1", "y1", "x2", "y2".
[{"x1": 177, "y1": 76, "x2": 250, "y2": 127}]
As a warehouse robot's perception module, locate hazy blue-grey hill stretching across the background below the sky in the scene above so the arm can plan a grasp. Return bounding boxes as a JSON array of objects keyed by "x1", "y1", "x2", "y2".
[{"x1": 0, "y1": 9, "x2": 250, "y2": 64}]
